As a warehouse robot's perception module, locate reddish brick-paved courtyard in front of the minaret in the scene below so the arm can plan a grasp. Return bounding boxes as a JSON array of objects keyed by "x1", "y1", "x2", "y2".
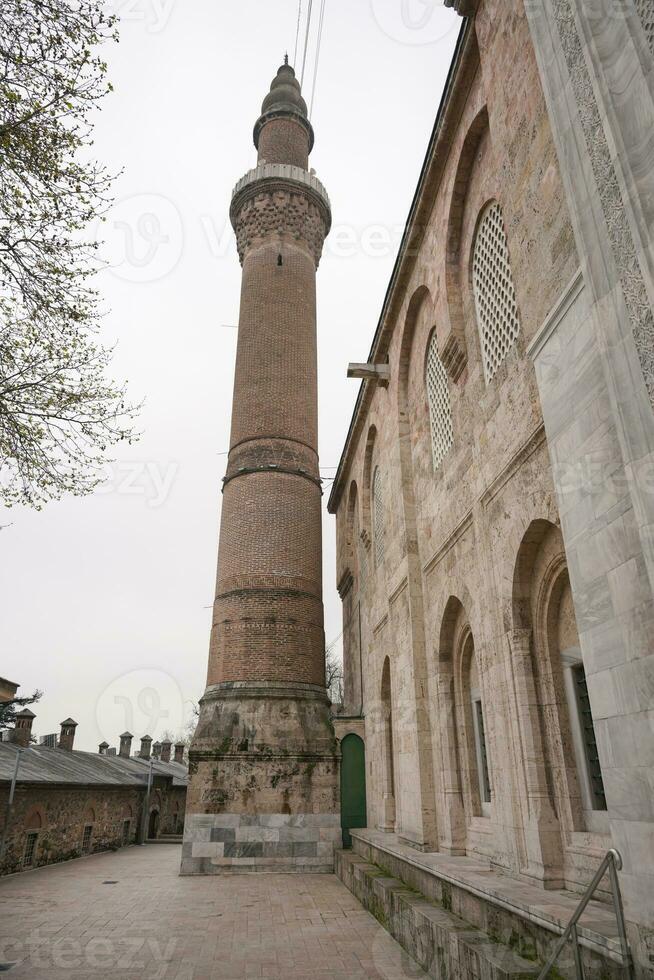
[{"x1": 0, "y1": 844, "x2": 424, "y2": 980}]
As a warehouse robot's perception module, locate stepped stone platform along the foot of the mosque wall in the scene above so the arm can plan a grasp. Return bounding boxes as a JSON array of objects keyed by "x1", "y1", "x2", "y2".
[{"x1": 335, "y1": 830, "x2": 632, "y2": 980}]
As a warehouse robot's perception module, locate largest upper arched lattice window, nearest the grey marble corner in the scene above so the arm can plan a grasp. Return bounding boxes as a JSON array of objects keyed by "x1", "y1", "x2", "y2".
[{"x1": 472, "y1": 201, "x2": 520, "y2": 384}]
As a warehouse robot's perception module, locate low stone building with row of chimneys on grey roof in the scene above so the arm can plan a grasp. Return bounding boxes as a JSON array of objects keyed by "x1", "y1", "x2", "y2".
[{"x1": 0, "y1": 709, "x2": 188, "y2": 874}]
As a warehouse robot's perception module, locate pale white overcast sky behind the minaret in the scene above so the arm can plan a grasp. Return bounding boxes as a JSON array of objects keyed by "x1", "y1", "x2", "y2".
[{"x1": 0, "y1": 0, "x2": 460, "y2": 750}]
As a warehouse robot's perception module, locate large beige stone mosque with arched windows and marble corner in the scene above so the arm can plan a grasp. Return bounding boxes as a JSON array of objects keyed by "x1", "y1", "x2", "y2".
[{"x1": 329, "y1": 0, "x2": 654, "y2": 975}]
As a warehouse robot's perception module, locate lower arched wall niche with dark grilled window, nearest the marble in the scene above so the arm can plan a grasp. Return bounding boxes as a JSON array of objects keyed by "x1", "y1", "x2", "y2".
[{"x1": 509, "y1": 519, "x2": 609, "y2": 885}]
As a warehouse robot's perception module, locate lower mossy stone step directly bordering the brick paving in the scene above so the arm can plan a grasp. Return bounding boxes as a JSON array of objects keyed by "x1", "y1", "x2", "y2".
[{"x1": 336, "y1": 851, "x2": 540, "y2": 980}]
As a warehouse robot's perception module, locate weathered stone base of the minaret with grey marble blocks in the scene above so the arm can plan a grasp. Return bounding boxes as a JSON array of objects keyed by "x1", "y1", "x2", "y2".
[{"x1": 181, "y1": 681, "x2": 341, "y2": 875}]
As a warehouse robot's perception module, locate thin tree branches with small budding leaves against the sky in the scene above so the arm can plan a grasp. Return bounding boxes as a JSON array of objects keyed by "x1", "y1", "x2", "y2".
[{"x1": 0, "y1": 0, "x2": 139, "y2": 507}]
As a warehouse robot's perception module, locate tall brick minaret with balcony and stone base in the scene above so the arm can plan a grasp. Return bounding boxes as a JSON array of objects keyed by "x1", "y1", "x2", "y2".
[{"x1": 182, "y1": 64, "x2": 340, "y2": 874}]
